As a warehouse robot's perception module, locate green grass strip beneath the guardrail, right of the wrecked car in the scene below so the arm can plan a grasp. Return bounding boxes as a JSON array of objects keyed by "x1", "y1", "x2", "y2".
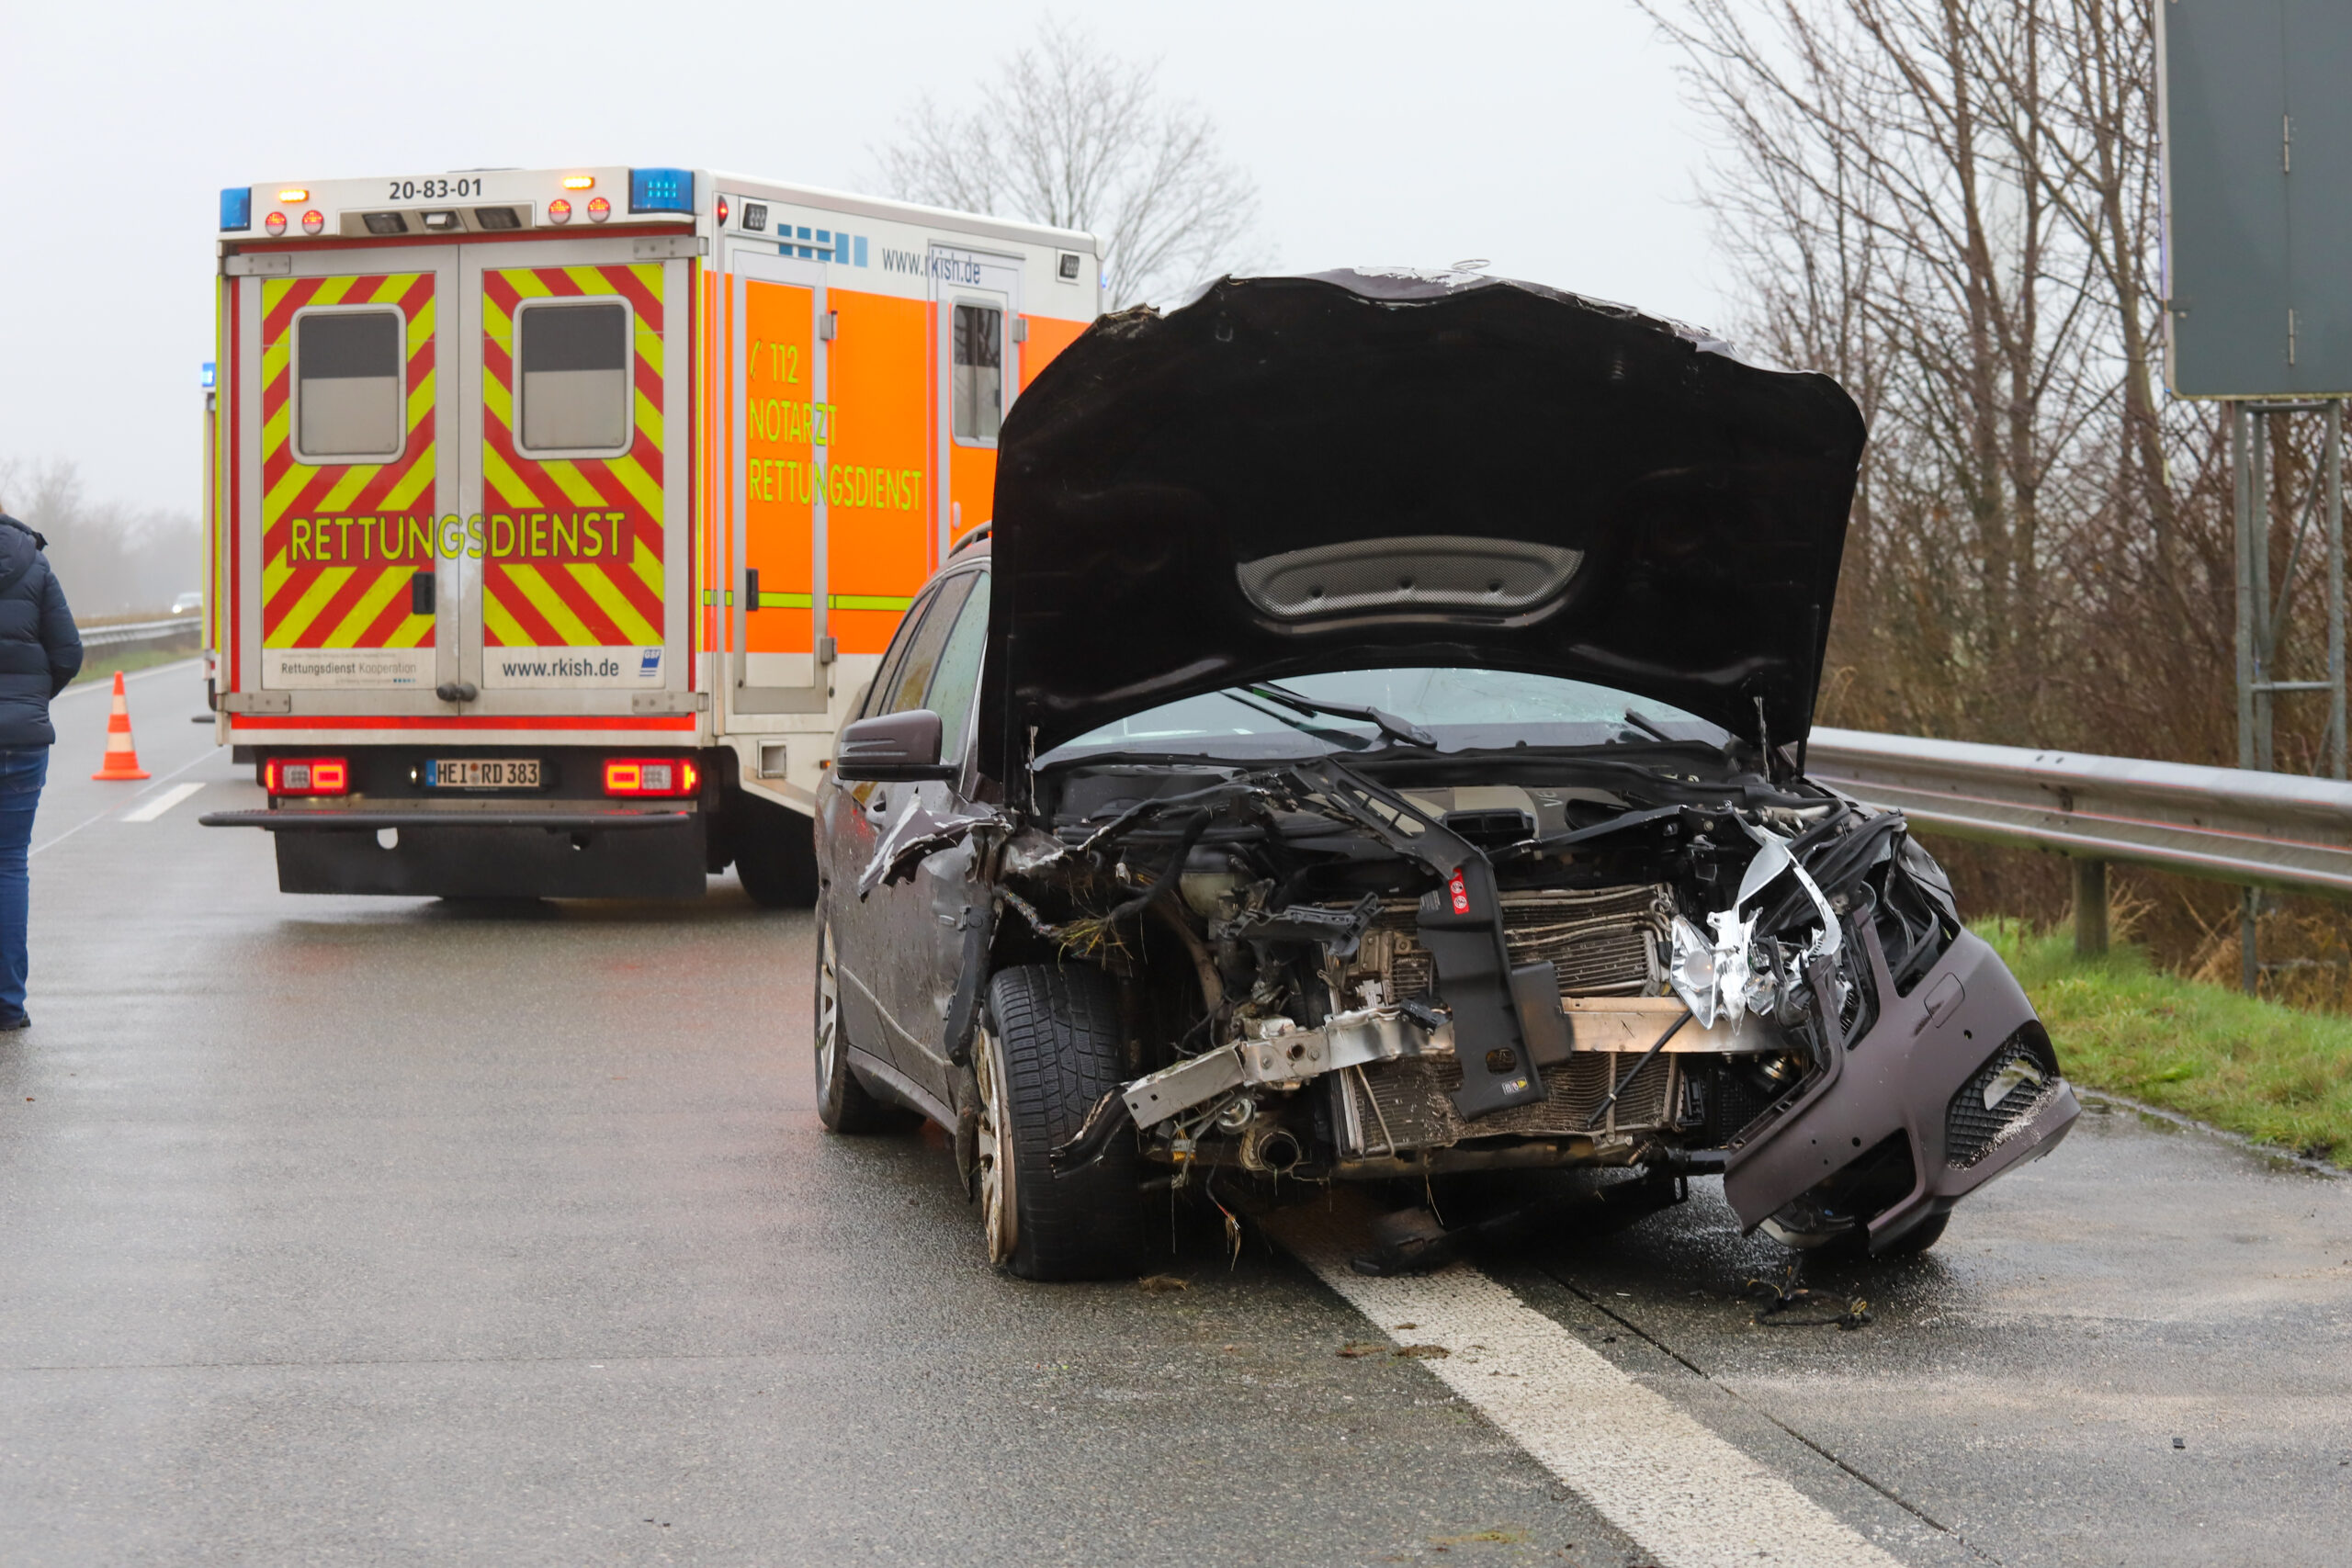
[{"x1": 1975, "y1": 919, "x2": 2352, "y2": 1164}]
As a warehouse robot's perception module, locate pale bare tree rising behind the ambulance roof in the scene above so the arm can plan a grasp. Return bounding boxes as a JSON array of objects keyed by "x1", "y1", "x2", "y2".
[{"x1": 877, "y1": 17, "x2": 1259, "y2": 310}]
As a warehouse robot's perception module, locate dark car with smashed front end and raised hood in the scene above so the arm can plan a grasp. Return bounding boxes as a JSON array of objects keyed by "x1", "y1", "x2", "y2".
[{"x1": 816, "y1": 270, "x2": 2076, "y2": 1279}]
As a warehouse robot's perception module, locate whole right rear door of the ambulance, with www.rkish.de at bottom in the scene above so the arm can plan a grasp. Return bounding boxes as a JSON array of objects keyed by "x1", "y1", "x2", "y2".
[{"x1": 454, "y1": 235, "x2": 696, "y2": 715}]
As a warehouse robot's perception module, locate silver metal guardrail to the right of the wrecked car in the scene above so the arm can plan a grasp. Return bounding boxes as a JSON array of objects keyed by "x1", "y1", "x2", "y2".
[{"x1": 1806, "y1": 728, "x2": 2352, "y2": 968}]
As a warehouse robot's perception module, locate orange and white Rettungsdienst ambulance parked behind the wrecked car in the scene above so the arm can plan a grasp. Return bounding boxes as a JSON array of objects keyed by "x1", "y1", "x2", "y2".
[{"x1": 202, "y1": 167, "x2": 1101, "y2": 905}]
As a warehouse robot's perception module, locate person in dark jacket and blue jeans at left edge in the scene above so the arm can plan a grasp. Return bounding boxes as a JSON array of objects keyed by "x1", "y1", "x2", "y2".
[{"x1": 0, "y1": 513, "x2": 83, "y2": 1030}]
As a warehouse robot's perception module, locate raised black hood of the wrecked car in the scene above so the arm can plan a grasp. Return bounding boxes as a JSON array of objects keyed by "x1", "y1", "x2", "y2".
[{"x1": 981, "y1": 273, "x2": 1863, "y2": 778}]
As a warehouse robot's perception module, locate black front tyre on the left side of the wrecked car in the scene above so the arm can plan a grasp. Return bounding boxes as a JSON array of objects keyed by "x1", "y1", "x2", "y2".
[{"x1": 978, "y1": 964, "x2": 1148, "y2": 1279}]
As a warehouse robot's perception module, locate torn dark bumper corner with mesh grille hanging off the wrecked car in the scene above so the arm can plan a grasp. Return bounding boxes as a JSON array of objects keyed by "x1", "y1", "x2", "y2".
[{"x1": 1724, "y1": 924, "x2": 2082, "y2": 1251}]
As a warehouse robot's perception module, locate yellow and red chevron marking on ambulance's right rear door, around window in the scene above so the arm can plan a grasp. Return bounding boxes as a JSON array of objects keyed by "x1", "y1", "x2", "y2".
[{"x1": 482, "y1": 261, "x2": 663, "y2": 649}]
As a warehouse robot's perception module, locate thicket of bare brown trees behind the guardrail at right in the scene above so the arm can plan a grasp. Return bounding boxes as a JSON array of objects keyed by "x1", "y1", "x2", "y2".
[{"x1": 1637, "y1": 0, "x2": 2352, "y2": 1006}]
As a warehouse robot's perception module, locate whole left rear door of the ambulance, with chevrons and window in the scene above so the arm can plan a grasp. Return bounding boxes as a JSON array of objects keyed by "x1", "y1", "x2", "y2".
[{"x1": 223, "y1": 244, "x2": 461, "y2": 712}]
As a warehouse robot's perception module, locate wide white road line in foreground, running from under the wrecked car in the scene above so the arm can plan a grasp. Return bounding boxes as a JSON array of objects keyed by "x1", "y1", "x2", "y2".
[{"x1": 1275, "y1": 1213, "x2": 1898, "y2": 1568}]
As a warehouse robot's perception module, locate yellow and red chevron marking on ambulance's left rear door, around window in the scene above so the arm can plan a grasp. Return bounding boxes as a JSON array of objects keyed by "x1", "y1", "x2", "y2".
[{"x1": 261, "y1": 273, "x2": 433, "y2": 649}]
